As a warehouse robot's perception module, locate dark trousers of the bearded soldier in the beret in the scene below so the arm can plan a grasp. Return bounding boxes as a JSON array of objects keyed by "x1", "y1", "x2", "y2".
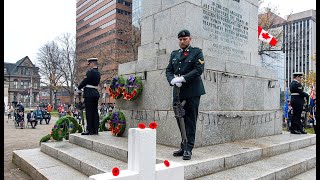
[{"x1": 173, "y1": 96, "x2": 200, "y2": 151}]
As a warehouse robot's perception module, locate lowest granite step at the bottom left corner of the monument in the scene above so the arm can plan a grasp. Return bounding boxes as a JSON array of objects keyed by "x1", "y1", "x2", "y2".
[{"x1": 12, "y1": 148, "x2": 89, "y2": 180}]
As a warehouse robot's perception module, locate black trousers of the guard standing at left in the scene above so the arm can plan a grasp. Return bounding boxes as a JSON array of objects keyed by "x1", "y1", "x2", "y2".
[{"x1": 84, "y1": 97, "x2": 99, "y2": 134}]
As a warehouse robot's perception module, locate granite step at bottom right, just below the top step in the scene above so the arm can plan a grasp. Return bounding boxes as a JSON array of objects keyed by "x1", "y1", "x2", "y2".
[{"x1": 196, "y1": 145, "x2": 316, "y2": 180}]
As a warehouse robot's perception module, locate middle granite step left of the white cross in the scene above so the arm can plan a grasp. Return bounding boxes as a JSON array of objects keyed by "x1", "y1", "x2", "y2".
[{"x1": 40, "y1": 141, "x2": 127, "y2": 176}]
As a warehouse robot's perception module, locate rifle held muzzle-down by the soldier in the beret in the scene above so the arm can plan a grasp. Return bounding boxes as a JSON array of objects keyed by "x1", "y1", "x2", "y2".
[{"x1": 173, "y1": 86, "x2": 188, "y2": 150}]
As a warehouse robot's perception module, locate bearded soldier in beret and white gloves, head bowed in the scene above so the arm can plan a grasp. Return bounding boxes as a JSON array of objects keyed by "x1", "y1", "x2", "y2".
[{"x1": 166, "y1": 30, "x2": 205, "y2": 160}]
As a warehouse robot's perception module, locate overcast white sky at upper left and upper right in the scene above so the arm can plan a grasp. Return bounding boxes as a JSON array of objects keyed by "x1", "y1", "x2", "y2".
[{"x1": 4, "y1": 0, "x2": 316, "y2": 63}]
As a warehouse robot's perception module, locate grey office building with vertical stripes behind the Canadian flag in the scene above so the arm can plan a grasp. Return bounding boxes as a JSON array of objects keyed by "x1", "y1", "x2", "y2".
[{"x1": 282, "y1": 10, "x2": 316, "y2": 86}]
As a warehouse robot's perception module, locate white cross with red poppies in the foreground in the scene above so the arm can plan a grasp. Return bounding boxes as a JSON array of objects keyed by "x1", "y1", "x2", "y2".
[{"x1": 89, "y1": 128, "x2": 184, "y2": 180}]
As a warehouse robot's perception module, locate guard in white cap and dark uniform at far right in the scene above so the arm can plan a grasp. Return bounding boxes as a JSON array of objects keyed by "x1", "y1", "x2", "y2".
[{"x1": 290, "y1": 72, "x2": 309, "y2": 134}]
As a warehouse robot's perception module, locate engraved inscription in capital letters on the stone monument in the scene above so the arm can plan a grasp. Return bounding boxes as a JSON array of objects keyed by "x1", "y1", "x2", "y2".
[{"x1": 202, "y1": 0, "x2": 249, "y2": 59}]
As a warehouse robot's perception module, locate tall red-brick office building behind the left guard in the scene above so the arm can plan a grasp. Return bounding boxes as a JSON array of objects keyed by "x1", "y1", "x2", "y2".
[{"x1": 76, "y1": 0, "x2": 132, "y2": 81}]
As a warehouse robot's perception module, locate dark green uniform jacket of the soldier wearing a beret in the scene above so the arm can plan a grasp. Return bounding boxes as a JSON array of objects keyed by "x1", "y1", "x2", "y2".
[{"x1": 166, "y1": 46, "x2": 206, "y2": 99}]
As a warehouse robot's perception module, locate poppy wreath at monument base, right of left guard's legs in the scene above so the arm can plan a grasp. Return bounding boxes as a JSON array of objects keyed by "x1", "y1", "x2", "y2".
[{"x1": 108, "y1": 111, "x2": 126, "y2": 137}]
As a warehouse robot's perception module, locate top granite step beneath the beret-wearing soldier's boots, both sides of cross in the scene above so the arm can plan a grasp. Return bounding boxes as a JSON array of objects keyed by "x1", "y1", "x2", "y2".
[{"x1": 69, "y1": 132, "x2": 316, "y2": 179}]
